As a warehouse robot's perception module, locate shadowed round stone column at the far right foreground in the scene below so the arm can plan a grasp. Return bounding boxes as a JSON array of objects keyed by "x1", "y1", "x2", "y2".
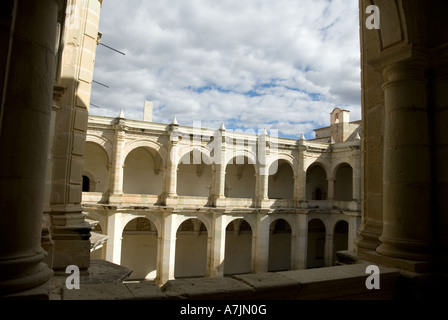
[{"x1": 377, "y1": 57, "x2": 431, "y2": 261}]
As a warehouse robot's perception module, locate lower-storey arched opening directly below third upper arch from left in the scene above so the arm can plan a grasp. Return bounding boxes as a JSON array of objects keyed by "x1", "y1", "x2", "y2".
[{"x1": 174, "y1": 219, "x2": 208, "y2": 278}]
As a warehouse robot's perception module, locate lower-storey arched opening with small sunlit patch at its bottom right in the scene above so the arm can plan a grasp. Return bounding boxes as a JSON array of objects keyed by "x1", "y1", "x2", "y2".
[{"x1": 121, "y1": 217, "x2": 158, "y2": 280}]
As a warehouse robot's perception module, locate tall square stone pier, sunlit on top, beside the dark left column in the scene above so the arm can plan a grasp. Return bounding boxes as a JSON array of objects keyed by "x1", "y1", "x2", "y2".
[{"x1": 50, "y1": 0, "x2": 101, "y2": 272}]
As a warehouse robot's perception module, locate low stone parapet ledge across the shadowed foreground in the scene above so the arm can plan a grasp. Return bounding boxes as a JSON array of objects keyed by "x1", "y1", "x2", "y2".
[{"x1": 62, "y1": 263, "x2": 400, "y2": 300}]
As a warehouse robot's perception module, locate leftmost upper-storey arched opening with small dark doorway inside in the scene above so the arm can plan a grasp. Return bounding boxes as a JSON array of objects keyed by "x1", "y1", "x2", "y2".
[{"x1": 82, "y1": 141, "x2": 109, "y2": 192}]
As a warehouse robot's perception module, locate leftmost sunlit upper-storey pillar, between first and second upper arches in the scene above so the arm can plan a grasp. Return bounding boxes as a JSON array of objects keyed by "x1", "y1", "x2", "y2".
[{"x1": 109, "y1": 122, "x2": 126, "y2": 203}]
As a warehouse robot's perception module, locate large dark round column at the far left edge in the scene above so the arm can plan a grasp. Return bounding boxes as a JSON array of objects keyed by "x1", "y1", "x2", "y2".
[{"x1": 0, "y1": 0, "x2": 59, "y2": 296}]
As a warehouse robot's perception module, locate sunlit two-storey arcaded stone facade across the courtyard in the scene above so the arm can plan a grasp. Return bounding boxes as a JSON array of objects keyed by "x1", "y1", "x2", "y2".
[{"x1": 83, "y1": 107, "x2": 361, "y2": 284}]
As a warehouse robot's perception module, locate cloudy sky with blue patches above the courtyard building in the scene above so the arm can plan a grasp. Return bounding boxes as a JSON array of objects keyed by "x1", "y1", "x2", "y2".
[{"x1": 90, "y1": 0, "x2": 361, "y2": 139}]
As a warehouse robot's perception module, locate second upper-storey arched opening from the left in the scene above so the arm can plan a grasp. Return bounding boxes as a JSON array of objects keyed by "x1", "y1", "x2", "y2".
[{"x1": 123, "y1": 147, "x2": 163, "y2": 195}]
